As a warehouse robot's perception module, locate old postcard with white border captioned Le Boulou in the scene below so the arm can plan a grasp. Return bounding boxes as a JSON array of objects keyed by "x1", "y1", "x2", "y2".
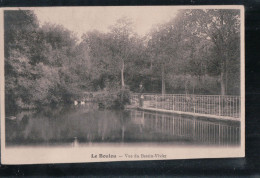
[{"x1": 0, "y1": 6, "x2": 245, "y2": 164}]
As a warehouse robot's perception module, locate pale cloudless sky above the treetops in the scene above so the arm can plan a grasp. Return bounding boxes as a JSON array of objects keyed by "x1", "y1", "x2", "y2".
[{"x1": 34, "y1": 6, "x2": 178, "y2": 38}]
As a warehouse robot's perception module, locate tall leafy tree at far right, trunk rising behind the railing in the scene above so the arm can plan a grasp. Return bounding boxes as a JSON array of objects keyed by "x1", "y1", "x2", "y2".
[{"x1": 181, "y1": 9, "x2": 240, "y2": 95}]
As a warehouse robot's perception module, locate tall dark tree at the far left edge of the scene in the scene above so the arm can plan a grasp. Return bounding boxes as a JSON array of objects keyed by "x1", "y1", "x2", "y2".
[{"x1": 4, "y1": 10, "x2": 39, "y2": 111}]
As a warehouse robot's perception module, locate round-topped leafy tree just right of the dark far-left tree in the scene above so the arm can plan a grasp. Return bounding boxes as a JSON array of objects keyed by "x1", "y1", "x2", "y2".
[{"x1": 38, "y1": 24, "x2": 80, "y2": 104}]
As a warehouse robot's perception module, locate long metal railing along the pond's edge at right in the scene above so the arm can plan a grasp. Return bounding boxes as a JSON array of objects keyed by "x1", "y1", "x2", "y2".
[{"x1": 131, "y1": 94, "x2": 240, "y2": 118}]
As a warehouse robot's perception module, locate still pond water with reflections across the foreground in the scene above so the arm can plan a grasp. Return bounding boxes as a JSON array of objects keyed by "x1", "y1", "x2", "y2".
[{"x1": 6, "y1": 103, "x2": 240, "y2": 146}]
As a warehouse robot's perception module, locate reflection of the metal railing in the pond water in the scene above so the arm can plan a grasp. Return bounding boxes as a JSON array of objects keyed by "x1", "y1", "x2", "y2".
[{"x1": 135, "y1": 111, "x2": 240, "y2": 146}]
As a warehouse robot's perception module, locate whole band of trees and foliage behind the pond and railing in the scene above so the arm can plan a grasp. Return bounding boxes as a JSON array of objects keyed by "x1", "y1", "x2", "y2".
[{"x1": 4, "y1": 9, "x2": 240, "y2": 110}]
